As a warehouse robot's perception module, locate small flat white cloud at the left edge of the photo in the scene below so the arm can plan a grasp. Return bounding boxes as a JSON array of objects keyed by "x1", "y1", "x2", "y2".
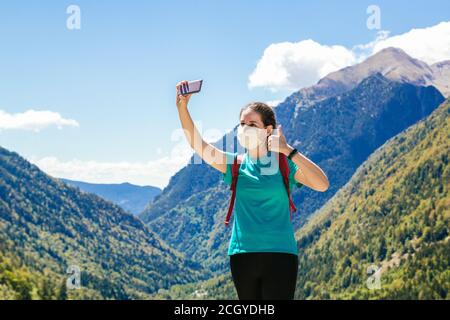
[{"x1": 0, "y1": 110, "x2": 79, "y2": 132}]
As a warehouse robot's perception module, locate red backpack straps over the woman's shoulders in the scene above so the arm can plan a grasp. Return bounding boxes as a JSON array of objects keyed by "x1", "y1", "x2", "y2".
[{"x1": 225, "y1": 153, "x2": 297, "y2": 227}]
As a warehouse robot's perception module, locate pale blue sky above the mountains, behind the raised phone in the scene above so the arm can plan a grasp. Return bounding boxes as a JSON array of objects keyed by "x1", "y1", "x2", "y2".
[{"x1": 0, "y1": 0, "x2": 450, "y2": 187}]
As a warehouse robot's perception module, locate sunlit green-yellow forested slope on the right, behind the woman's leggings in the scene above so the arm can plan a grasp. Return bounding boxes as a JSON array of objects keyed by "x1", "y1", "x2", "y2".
[{"x1": 155, "y1": 99, "x2": 450, "y2": 300}]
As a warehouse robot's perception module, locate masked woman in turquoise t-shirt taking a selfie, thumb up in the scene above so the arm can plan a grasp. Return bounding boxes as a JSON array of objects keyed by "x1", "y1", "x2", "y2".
[{"x1": 176, "y1": 81, "x2": 329, "y2": 300}]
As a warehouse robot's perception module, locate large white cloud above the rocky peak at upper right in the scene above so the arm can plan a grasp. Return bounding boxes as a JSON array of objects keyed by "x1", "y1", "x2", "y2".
[{"x1": 248, "y1": 21, "x2": 450, "y2": 91}]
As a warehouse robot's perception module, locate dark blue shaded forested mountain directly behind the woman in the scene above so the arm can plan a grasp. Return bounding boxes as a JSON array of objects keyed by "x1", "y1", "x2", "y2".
[{"x1": 141, "y1": 73, "x2": 444, "y2": 273}]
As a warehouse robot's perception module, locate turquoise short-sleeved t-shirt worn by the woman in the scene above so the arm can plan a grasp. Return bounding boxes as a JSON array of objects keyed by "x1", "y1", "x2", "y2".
[{"x1": 223, "y1": 151, "x2": 303, "y2": 255}]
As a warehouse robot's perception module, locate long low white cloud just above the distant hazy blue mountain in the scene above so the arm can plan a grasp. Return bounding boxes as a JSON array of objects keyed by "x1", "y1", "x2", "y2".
[{"x1": 28, "y1": 144, "x2": 193, "y2": 188}]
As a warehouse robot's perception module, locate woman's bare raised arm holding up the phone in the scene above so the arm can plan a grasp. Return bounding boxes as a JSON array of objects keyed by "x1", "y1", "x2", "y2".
[{"x1": 176, "y1": 81, "x2": 227, "y2": 173}]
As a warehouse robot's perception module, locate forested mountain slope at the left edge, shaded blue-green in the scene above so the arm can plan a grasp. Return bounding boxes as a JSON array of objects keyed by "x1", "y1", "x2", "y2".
[{"x1": 0, "y1": 148, "x2": 208, "y2": 299}]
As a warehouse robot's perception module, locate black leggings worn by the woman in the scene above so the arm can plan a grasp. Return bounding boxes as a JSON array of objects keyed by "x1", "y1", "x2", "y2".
[{"x1": 230, "y1": 252, "x2": 298, "y2": 300}]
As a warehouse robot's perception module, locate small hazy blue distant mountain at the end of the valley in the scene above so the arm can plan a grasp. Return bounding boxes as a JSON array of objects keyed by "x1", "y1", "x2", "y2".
[{"x1": 60, "y1": 179, "x2": 161, "y2": 215}]
